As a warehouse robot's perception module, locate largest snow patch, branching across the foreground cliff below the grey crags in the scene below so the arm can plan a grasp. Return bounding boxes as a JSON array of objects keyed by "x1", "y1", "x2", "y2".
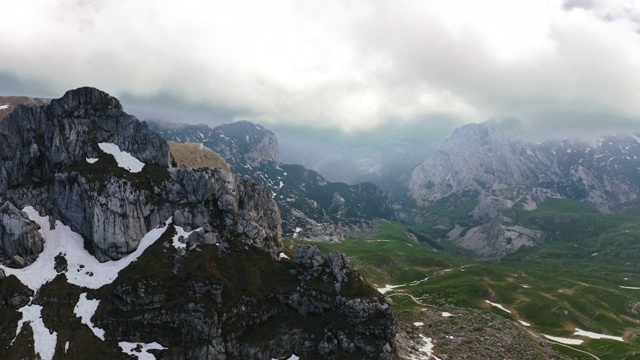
[{"x1": 0, "y1": 206, "x2": 171, "y2": 291}]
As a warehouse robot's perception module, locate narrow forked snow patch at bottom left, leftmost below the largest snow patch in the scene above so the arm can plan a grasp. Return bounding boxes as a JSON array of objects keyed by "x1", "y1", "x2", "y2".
[{"x1": 11, "y1": 305, "x2": 58, "y2": 360}]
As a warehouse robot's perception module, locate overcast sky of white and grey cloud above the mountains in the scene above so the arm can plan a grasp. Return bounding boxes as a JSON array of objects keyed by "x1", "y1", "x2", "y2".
[{"x1": 0, "y1": 0, "x2": 640, "y2": 138}]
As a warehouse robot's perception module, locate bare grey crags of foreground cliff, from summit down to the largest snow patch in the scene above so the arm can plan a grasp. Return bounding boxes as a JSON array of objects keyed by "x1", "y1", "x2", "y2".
[{"x1": 0, "y1": 88, "x2": 281, "y2": 261}]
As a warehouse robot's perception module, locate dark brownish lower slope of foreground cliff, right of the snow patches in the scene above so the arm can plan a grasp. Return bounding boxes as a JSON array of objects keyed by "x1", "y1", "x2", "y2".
[{"x1": 96, "y1": 241, "x2": 397, "y2": 360}]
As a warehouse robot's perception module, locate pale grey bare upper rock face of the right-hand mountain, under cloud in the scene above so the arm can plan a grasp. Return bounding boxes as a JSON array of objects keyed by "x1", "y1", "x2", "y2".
[{"x1": 408, "y1": 124, "x2": 640, "y2": 212}]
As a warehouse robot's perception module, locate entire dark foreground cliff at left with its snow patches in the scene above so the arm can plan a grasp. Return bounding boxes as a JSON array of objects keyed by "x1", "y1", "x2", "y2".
[{"x1": 0, "y1": 88, "x2": 396, "y2": 359}]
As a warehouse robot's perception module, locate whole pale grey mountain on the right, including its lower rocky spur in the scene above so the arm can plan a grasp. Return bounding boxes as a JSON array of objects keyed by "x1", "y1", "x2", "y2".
[{"x1": 390, "y1": 124, "x2": 640, "y2": 259}]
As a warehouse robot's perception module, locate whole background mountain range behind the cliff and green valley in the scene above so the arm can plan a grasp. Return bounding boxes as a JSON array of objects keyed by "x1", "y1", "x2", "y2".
[{"x1": 150, "y1": 115, "x2": 640, "y2": 261}]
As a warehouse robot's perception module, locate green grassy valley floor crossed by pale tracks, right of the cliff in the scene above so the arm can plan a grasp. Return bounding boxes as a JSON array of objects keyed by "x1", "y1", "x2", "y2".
[{"x1": 289, "y1": 199, "x2": 640, "y2": 359}]
